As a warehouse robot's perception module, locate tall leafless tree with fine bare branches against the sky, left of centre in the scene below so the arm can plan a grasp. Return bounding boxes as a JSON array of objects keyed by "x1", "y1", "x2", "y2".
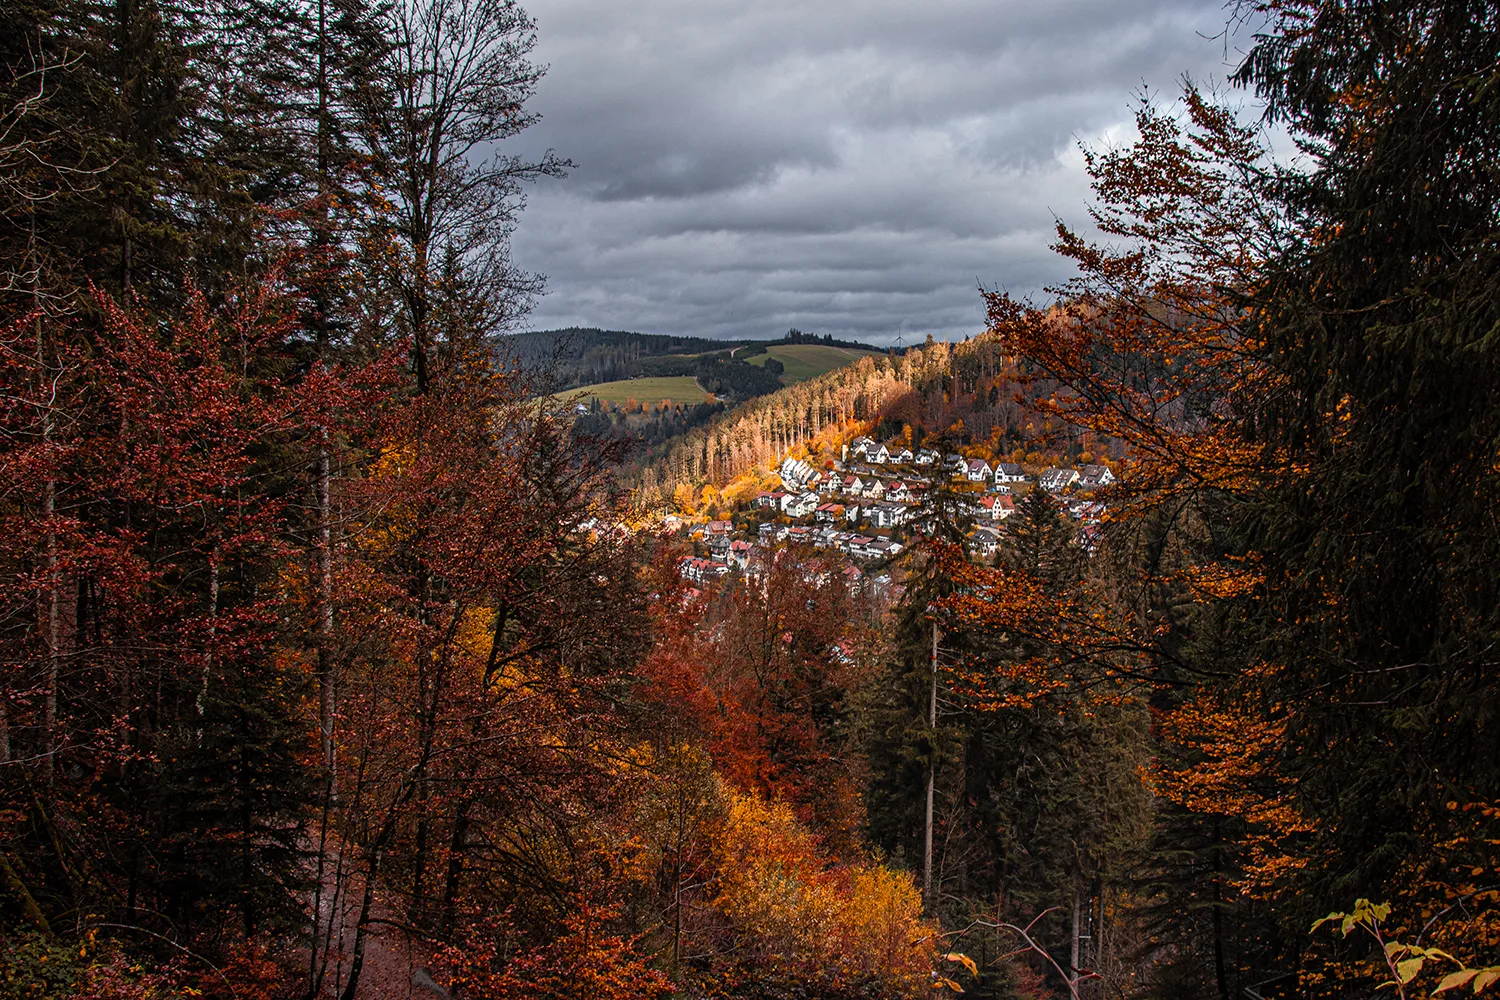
[{"x1": 371, "y1": 0, "x2": 569, "y2": 391}]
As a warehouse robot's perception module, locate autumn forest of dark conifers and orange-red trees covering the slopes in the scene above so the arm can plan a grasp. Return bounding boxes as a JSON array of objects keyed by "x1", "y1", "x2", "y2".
[{"x1": 0, "y1": 0, "x2": 1500, "y2": 1000}]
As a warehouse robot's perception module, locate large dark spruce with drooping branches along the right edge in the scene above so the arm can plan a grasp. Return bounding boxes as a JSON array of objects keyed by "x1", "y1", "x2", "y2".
[{"x1": 1239, "y1": 0, "x2": 1500, "y2": 904}]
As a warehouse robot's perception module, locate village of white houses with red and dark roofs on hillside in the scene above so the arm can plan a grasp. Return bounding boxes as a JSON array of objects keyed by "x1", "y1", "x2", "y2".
[{"x1": 663, "y1": 436, "x2": 1116, "y2": 601}]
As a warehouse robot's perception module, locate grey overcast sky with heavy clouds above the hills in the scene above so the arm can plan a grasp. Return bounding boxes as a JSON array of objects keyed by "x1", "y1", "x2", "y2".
[{"x1": 515, "y1": 0, "x2": 1242, "y2": 343}]
